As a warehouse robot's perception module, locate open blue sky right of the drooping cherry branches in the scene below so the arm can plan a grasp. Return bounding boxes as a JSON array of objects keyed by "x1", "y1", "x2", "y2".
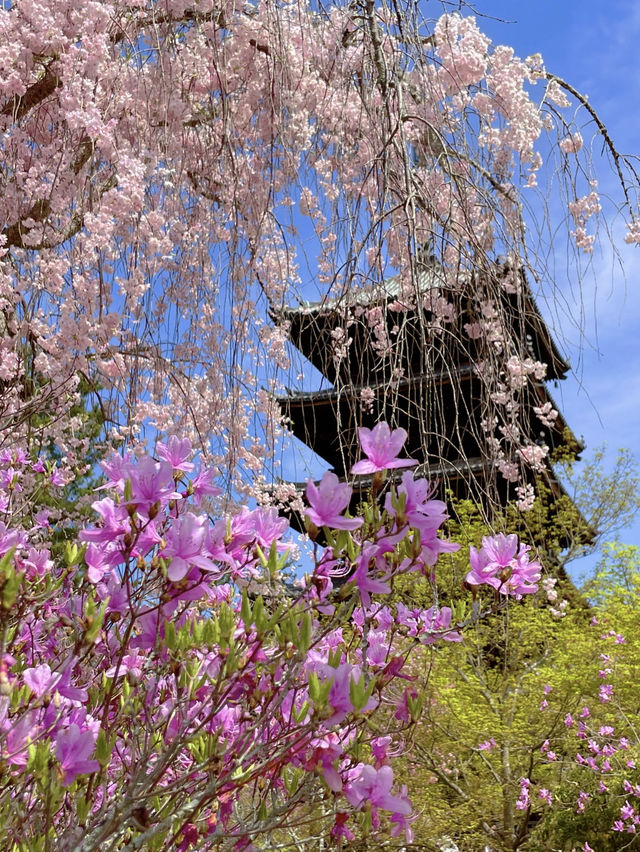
[{"x1": 474, "y1": 0, "x2": 640, "y2": 576}]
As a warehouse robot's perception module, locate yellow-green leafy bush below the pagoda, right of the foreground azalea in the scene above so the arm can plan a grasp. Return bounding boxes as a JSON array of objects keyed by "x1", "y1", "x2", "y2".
[{"x1": 404, "y1": 600, "x2": 597, "y2": 850}]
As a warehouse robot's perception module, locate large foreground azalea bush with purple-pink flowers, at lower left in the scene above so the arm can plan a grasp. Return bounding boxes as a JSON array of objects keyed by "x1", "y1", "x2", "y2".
[{"x1": 0, "y1": 423, "x2": 540, "y2": 852}]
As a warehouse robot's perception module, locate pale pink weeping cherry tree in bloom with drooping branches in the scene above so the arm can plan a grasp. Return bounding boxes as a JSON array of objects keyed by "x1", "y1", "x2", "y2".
[{"x1": 0, "y1": 0, "x2": 637, "y2": 500}]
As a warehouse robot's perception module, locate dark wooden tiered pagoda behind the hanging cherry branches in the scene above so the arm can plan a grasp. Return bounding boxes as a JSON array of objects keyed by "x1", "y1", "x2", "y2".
[{"x1": 273, "y1": 260, "x2": 582, "y2": 544}]
